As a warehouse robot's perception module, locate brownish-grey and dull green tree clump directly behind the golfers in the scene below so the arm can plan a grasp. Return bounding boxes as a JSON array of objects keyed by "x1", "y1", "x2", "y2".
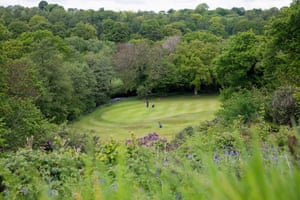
[{"x1": 114, "y1": 40, "x2": 177, "y2": 95}]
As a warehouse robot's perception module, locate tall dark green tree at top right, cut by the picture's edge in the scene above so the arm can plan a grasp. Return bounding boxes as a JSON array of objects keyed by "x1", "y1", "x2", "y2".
[{"x1": 264, "y1": 0, "x2": 300, "y2": 86}]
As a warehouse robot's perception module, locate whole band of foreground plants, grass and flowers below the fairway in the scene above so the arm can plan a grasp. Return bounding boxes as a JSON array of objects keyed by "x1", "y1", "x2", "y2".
[{"x1": 0, "y1": 118, "x2": 300, "y2": 200}]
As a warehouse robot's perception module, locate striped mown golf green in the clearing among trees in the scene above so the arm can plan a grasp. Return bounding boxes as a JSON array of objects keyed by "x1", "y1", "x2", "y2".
[{"x1": 71, "y1": 96, "x2": 220, "y2": 140}]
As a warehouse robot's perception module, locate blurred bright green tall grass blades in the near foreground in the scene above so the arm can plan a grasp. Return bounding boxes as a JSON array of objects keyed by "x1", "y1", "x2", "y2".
[{"x1": 67, "y1": 141, "x2": 300, "y2": 200}]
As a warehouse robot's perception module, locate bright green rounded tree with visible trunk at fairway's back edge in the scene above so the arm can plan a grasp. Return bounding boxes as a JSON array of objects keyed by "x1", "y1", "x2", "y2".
[{"x1": 173, "y1": 32, "x2": 220, "y2": 94}]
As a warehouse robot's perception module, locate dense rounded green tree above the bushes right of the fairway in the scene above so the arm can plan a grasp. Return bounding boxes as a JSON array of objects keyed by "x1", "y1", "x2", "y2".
[{"x1": 215, "y1": 31, "x2": 262, "y2": 88}]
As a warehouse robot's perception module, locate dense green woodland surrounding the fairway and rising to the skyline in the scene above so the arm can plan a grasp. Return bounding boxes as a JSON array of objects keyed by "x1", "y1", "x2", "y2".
[{"x1": 0, "y1": 0, "x2": 300, "y2": 199}]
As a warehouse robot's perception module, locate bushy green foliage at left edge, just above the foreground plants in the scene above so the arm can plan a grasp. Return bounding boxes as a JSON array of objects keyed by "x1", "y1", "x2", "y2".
[{"x1": 0, "y1": 96, "x2": 54, "y2": 150}]
